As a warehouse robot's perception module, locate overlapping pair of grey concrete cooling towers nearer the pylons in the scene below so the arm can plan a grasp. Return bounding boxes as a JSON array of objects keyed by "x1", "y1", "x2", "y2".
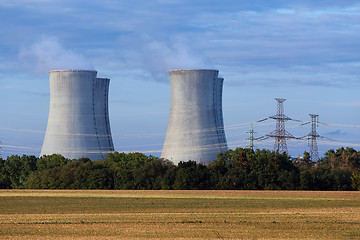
[{"x1": 161, "y1": 69, "x2": 227, "y2": 164}]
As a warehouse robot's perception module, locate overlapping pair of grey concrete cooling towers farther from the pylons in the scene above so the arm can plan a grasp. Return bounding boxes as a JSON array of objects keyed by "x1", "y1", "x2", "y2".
[{"x1": 40, "y1": 70, "x2": 114, "y2": 160}]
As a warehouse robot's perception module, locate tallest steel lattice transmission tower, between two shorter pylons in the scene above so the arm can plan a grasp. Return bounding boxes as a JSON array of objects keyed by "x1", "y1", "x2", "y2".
[{"x1": 257, "y1": 98, "x2": 299, "y2": 154}]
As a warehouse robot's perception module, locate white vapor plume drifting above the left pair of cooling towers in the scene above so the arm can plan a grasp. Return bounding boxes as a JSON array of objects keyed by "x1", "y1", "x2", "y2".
[{"x1": 19, "y1": 37, "x2": 94, "y2": 74}]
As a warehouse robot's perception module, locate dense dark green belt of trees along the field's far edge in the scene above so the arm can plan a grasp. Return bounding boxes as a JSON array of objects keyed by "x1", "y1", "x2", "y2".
[{"x1": 0, "y1": 148, "x2": 360, "y2": 191}]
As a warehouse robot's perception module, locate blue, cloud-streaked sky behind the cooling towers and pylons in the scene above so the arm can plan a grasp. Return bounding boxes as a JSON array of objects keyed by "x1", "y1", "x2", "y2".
[{"x1": 0, "y1": 0, "x2": 360, "y2": 157}]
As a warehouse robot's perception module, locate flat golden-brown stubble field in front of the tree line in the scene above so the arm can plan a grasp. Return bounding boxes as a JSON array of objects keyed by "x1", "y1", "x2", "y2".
[{"x1": 0, "y1": 190, "x2": 360, "y2": 239}]
